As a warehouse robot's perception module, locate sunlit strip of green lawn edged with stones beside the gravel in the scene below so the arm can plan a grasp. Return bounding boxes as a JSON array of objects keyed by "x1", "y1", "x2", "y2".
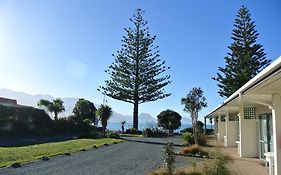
[{"x1": 0, "y1": 138, "x2": 121, "y2": 167}]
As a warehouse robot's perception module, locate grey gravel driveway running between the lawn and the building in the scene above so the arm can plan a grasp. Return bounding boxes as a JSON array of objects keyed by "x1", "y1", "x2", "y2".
[{"x1": 0, "y1": 138, "x2": 188, "y2": 175}]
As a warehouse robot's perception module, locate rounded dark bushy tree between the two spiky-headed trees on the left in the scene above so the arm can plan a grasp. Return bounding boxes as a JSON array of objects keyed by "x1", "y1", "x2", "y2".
[{"x1": 73, "y1": 98, "x2": 98, "y2": 125}]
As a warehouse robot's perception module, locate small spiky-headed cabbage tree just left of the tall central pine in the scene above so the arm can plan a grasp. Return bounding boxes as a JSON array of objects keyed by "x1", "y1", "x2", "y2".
[{"x1": 96, "y1": 104, "x2": 112, "y2": 136}]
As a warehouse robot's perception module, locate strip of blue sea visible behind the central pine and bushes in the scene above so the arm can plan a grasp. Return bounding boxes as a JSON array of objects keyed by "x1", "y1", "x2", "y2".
[{"x1": 106, "y1": 122, "x2": 211, "y2": 132}]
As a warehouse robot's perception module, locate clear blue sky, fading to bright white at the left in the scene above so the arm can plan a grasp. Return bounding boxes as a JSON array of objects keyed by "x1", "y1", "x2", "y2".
[{"x1": 0, "y1": 0, "x2": 281, "y2": 123}]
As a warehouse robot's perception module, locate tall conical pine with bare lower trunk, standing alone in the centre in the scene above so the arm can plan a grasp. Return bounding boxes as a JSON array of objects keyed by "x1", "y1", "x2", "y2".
[{"x1": 100, "y1": 9, "x2": 171, "y2": 129}]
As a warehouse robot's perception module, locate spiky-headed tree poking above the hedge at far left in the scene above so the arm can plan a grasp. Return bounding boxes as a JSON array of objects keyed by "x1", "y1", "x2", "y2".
[{"x1": 37, "y1": 98, "x2": 65, "y2": 120}]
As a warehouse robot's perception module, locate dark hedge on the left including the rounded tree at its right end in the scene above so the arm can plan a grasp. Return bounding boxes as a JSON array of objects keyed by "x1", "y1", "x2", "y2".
[{"x1": 0, "y1": 99, "x2": 99, "y2": 136}]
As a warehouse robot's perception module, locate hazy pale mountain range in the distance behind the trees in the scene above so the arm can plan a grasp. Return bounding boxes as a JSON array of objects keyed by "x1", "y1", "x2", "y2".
[{"x1": 0, "y1": 89, "x2": 160, "y2": 123}]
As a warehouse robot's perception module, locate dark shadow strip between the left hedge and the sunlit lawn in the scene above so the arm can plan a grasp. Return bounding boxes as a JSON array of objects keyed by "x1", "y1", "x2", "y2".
[{"x1": 0, "y1": 135, "x2": 77, "y2": 147}]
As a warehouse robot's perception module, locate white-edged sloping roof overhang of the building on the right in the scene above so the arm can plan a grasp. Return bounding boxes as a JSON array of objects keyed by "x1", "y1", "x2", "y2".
[{"x1": 206, "y1": 56, "x2": 281, "y2": 118}]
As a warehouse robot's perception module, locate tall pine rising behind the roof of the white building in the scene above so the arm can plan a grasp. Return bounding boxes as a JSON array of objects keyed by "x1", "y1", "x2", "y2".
[{"x1": 213, "y1": 6, "x2": 271, "y2": 97}]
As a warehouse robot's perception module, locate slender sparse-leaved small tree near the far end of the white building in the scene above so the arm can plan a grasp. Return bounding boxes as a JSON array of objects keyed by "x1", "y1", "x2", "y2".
[{"x1": 181, "y1": 87, "x2": 207, "y2": 144}]
